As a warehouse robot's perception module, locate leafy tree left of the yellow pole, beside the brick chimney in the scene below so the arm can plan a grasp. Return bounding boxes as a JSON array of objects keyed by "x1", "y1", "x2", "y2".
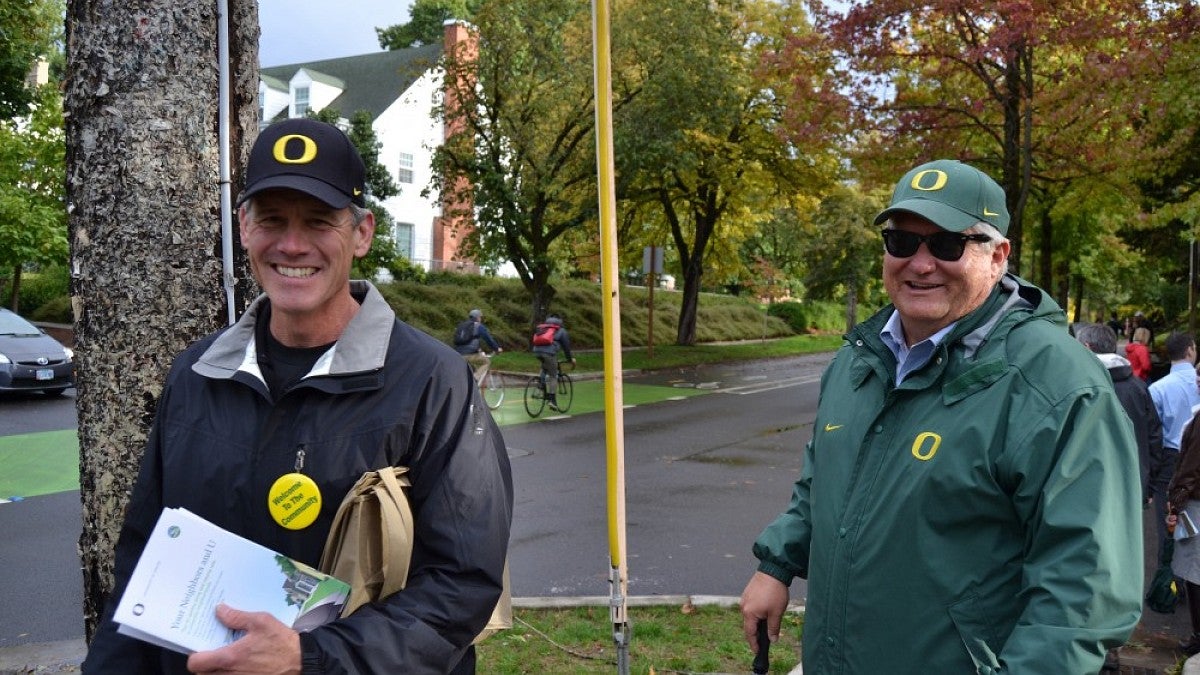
[{"x1": 431, "y1": 0, "x2": 635, "y2": 321}]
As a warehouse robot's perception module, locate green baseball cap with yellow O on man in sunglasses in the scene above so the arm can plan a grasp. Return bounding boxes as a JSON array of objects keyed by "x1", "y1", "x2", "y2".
[{"x1": 875, "y1": 160, "x2": 1008, "y2": 237}]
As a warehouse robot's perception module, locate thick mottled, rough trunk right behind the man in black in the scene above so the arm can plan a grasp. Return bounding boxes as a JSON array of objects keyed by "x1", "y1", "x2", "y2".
[{"x1": 65, "y1": 0, "x2": 258, "y2": 640}]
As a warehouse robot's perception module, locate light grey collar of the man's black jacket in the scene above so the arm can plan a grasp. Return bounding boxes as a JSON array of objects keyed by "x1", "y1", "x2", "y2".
[{"x1": 192, "y1": 281, "x2": 396, "y2": 381}]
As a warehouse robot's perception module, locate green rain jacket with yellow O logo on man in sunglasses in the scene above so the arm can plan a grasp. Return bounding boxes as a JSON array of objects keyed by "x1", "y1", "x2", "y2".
[{"x1": 754, "y1": 275, "x2": 1142, "y2": 675}]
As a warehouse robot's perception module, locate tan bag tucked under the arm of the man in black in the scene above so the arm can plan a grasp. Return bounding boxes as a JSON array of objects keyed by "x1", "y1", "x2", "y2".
[{"x1": 318, "y1": 466, "x2": 512, "y2": 643}]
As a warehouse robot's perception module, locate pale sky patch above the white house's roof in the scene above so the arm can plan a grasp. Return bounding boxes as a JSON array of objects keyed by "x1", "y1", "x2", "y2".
[{"x1": 258, "y1": 0, "x2": 412, "y2": 67}]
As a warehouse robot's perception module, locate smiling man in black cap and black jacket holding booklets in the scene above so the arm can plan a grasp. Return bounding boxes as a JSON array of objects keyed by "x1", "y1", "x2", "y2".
[{"x1": 83, "y1": 119, "x2": 512, "y2": 675}]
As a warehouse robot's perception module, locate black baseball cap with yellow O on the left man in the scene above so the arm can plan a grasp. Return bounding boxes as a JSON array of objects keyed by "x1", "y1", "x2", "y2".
[{"x1": 238, "y1": 118, "x2": 367, "y2": 209}]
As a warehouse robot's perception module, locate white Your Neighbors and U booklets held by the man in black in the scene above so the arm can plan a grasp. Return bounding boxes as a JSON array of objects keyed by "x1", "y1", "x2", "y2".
[{"x1": 113, "y1": 508, "x2": 350, "y2": 653}]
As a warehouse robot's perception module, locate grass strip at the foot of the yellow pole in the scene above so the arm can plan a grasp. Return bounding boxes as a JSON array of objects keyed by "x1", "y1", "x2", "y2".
[{"x1": 478, "y1": 598, "x2": 804, "y2": 675}]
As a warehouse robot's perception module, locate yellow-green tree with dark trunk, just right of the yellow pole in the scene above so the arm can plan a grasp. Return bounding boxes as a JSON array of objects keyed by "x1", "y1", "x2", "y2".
[{"x1": 617, "y1": 1, "x2": 838, "y2": 345}]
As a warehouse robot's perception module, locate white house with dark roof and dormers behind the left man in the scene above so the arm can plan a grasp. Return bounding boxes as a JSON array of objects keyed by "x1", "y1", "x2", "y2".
[{"x1": 258, "y1": 23, "x2": 478, "y2": 271}]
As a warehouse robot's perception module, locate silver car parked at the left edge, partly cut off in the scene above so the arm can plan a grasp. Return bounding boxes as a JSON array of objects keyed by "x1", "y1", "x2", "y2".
[{"x1": 0, "y1": 309, "x2": 74, "y2": 395}]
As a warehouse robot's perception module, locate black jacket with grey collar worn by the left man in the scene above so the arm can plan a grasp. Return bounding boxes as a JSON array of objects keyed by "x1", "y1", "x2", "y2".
[{"x1": 84, "y1": 282, "x2": 512, "y2": 675}]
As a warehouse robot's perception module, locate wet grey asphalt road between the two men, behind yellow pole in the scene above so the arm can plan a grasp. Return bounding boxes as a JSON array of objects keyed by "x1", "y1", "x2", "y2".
[{"x1": 504, "y1": 358, "x2": 824, "y2": 596}]
